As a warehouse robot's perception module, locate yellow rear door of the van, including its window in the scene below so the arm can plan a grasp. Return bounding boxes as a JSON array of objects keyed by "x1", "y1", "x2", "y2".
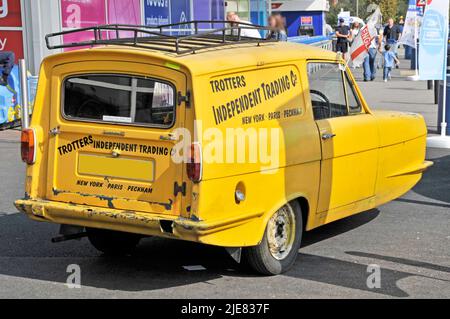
[{"x1": 47, "y1": 61, "x2": 186, "y2": 215}]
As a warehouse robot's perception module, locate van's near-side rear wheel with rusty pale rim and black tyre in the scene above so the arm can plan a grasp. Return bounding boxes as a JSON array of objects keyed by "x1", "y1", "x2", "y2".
[{"x1": 243, "y1": 201, "x2": 303, "y2": 276}]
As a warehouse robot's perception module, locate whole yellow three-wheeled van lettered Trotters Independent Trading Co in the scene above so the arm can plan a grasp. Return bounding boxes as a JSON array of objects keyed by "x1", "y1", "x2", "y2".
[{"x1": 16, "y1": 26, "x2": 431, "y2": 274}]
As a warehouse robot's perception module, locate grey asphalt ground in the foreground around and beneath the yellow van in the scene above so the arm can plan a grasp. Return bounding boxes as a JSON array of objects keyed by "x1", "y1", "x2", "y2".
[{"x1": 0, "y1": 138, "x2": 450, "y2": 299}]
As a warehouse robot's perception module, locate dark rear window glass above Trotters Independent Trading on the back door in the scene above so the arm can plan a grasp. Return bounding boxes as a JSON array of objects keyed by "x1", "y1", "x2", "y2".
[{"x1": 63, "y1": 75, "x2": 175, "y2": 128}]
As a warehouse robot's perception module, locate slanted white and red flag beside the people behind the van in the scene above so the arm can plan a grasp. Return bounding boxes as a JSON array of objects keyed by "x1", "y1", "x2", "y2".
[{"x1": 350, "y1": 8, "x2": 382, "y2": 67}]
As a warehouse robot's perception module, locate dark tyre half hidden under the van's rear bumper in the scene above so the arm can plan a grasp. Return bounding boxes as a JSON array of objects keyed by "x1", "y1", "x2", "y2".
[{"x1": 86, "y1": 228, "x2": 142, "y2": 256}]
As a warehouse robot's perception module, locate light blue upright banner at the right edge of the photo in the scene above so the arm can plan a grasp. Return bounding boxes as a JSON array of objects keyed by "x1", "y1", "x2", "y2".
[{"x1": 419, "y1": 0, "x2": 449, "y2": 80}]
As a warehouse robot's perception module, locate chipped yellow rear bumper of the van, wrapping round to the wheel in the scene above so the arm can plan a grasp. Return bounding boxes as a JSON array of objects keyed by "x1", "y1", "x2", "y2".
[{"x1": 15, "y1": 199, "x2": 263, "y2": 247}]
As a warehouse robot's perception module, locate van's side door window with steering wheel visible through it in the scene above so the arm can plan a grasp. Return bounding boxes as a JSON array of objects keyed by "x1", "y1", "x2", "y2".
[{"x1": 308, "y1": 63, "x2": 349, "y2": 121}]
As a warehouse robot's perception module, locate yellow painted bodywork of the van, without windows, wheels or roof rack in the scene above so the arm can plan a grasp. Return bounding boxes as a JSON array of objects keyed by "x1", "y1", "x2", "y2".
[{"x1": 16, "y1": 43, "x2": 431, "y2": 247}]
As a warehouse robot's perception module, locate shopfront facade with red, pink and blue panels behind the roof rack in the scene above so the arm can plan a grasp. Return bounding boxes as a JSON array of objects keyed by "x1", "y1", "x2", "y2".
[{"x1": 0, "y1": 0, "x2": 330, "y2": 74}]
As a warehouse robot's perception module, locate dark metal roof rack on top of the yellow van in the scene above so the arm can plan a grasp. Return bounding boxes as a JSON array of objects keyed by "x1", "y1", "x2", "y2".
[{"x1": 45, "y1": 20, "x2": 278, "y2": 55}]
